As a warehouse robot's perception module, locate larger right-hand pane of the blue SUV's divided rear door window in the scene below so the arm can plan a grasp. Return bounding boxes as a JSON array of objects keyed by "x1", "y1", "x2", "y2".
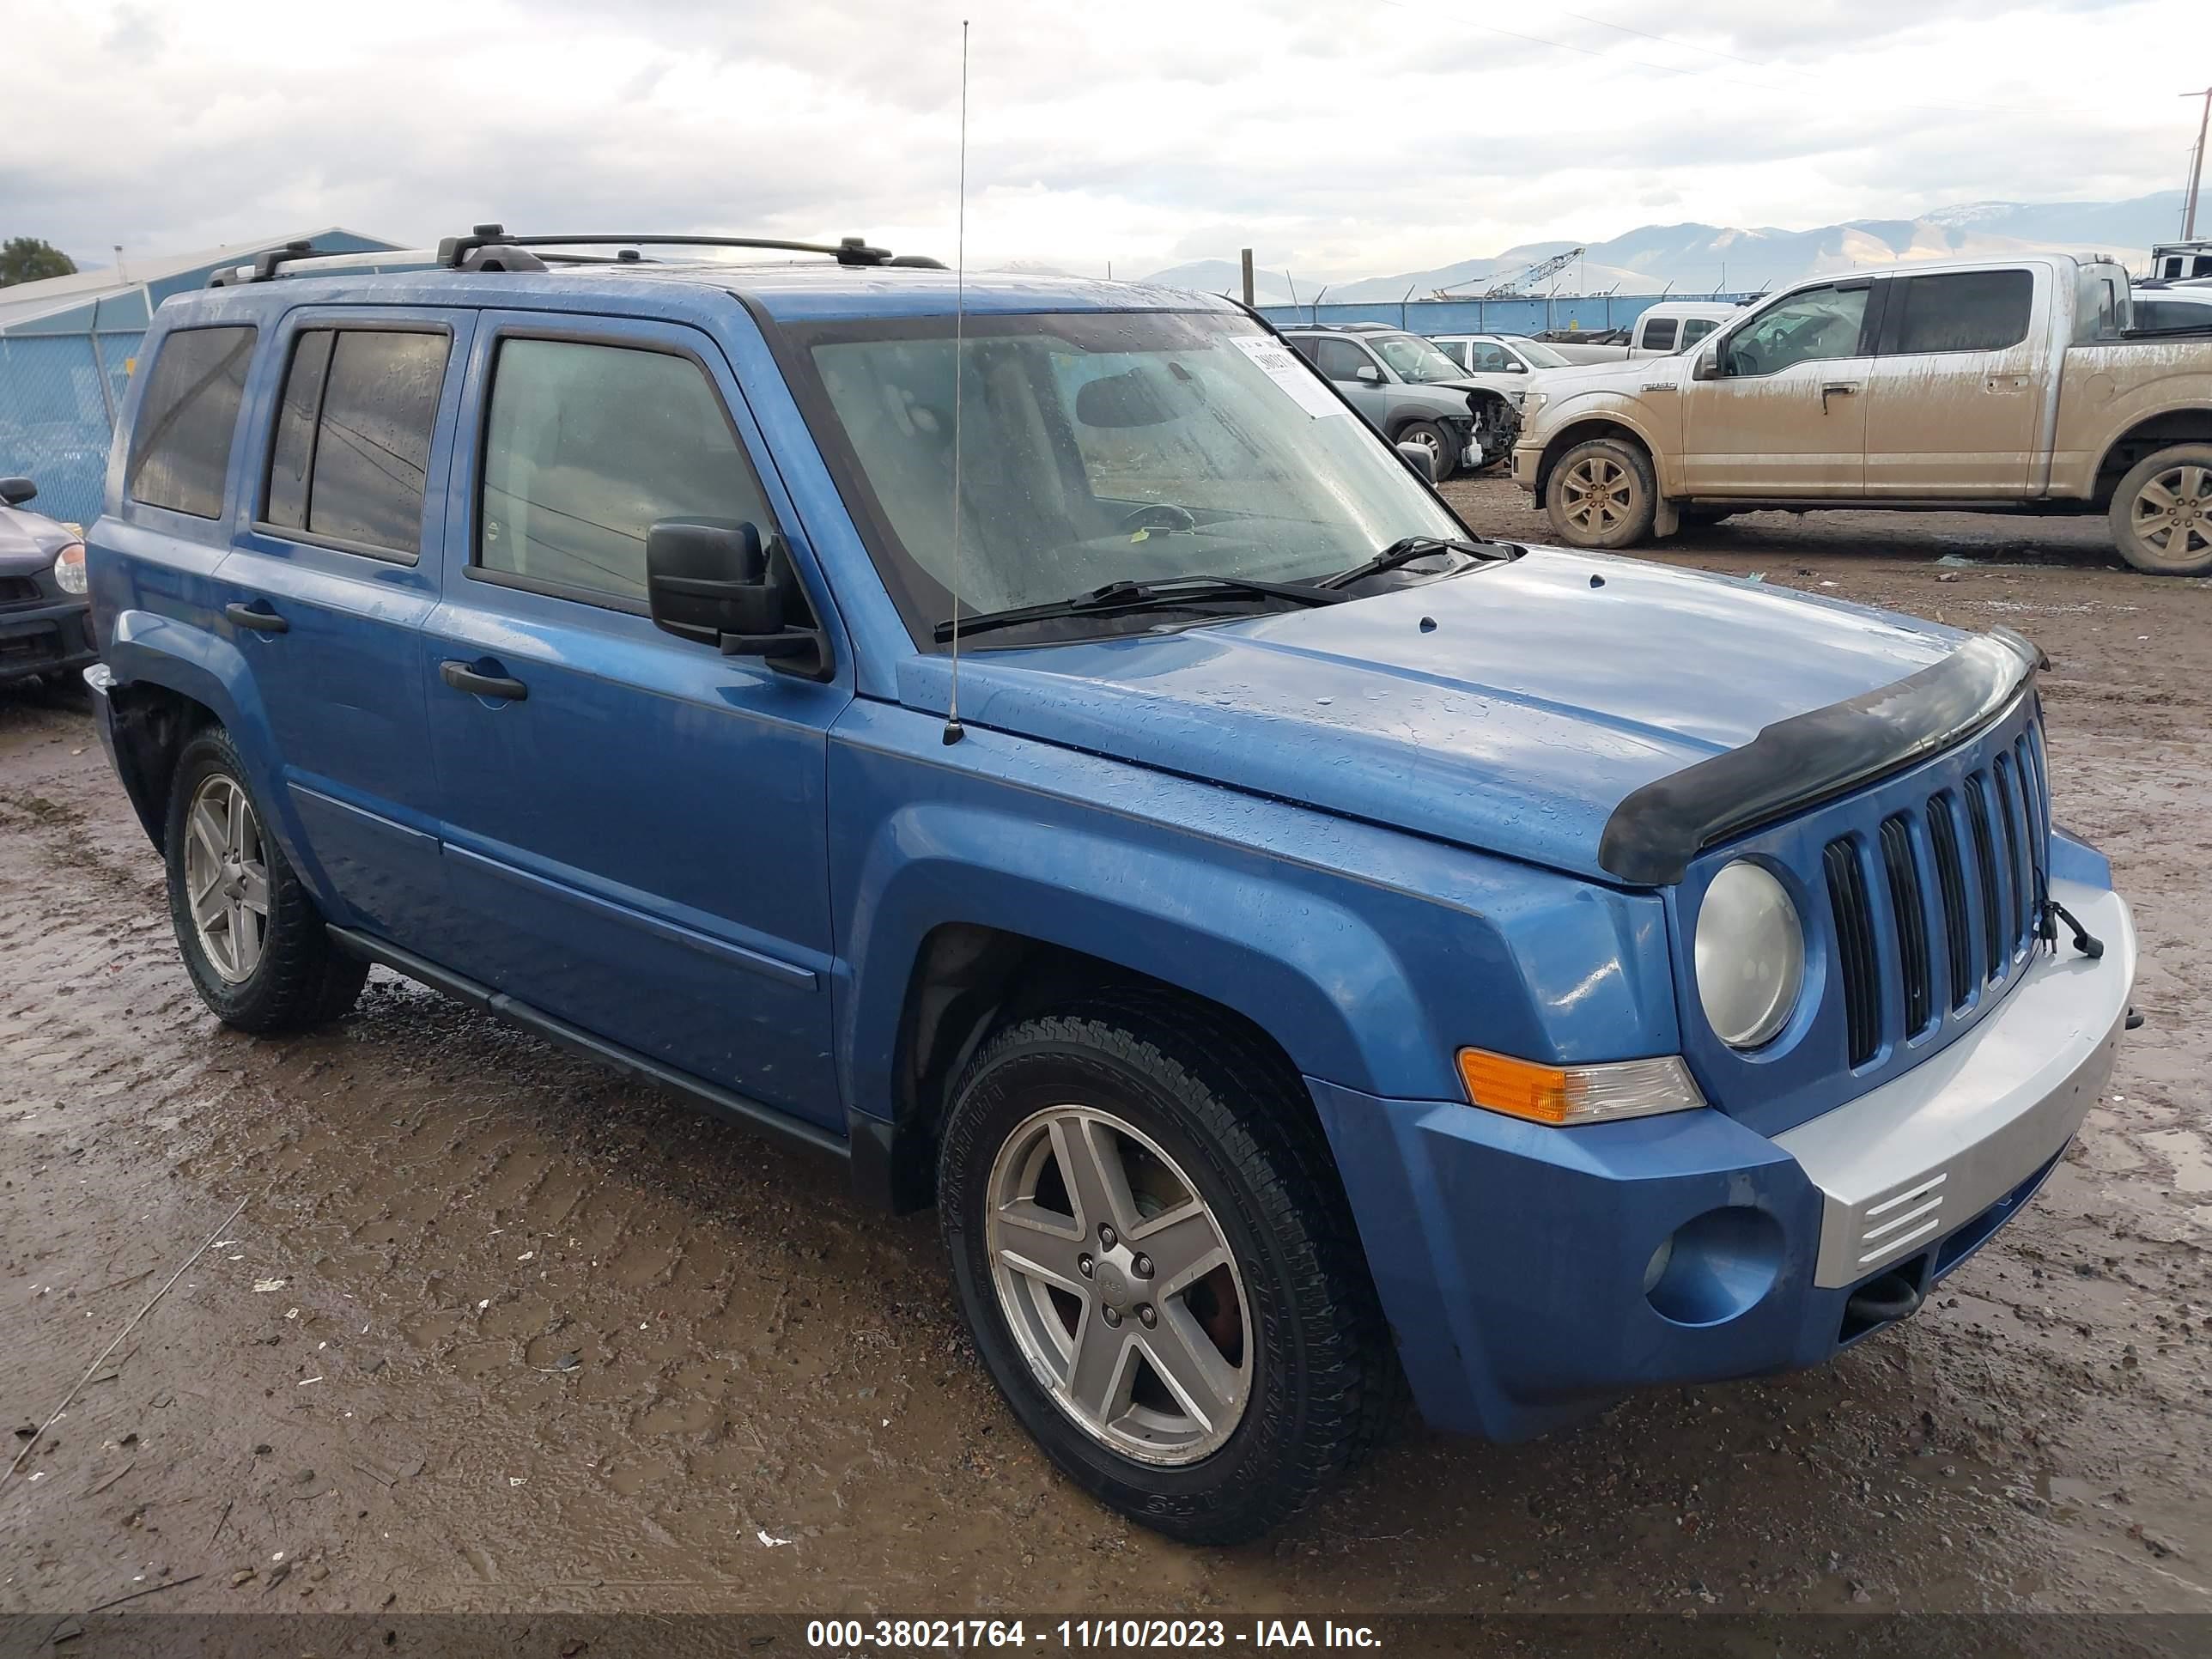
[{"x1": 307, "y1": 330, "x2": 447, "y2": 553}]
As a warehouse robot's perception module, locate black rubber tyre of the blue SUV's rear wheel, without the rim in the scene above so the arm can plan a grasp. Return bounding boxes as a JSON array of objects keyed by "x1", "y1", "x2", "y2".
[{"x1": 161, "y1": 726, "x2": 369, "y2": 1030}]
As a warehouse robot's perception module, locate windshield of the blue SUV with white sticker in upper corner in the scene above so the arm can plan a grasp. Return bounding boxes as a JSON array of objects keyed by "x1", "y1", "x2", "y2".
[{"x1": 792, "y1": 312, "x2": 1467, "y2": 648}]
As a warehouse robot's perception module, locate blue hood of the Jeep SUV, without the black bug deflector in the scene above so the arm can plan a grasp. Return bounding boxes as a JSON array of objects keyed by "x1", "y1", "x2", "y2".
[{"x1": 900, "y1": 549, "x2": 1964, "y2": 880}]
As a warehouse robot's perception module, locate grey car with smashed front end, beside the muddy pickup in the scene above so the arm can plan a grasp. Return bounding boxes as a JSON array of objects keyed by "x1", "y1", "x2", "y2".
[{"x1": 1283, "y1": 323, "x2": 1520, "y2": 477}]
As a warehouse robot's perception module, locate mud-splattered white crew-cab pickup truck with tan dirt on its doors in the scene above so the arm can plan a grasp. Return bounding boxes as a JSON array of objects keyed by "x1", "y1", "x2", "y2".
[{"x1": 1513, "y1": 254, "x2": 2212, "y2": 575}]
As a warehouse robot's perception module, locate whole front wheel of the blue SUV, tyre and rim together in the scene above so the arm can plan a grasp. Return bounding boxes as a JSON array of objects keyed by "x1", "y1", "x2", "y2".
[{"x1": 938, "y1": 995, "x2": 1398, "y2": 1544}]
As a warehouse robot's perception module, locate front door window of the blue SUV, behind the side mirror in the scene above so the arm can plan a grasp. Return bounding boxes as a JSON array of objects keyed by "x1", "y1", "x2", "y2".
[{"x1": 476, "y1": 341, "x2": 775, "y2": 604}]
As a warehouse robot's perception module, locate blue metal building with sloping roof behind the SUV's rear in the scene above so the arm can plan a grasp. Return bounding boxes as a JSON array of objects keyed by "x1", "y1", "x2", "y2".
[{"x1": 0, "y1": 226, "x2": 396, "y2": 525}]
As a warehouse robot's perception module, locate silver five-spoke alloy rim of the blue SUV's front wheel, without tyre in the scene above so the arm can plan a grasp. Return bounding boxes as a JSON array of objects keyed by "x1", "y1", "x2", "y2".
[{"x1": 987, "y1": 1106, "x2": 1252, "y2": 1464}]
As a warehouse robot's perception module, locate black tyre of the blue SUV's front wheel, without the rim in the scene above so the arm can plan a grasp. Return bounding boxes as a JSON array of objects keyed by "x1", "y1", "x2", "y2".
[{"x1": 938, "y1": 994, "x2": 1402, "y2": 1544}]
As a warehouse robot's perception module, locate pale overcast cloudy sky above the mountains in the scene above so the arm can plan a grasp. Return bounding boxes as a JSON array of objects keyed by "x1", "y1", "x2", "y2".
[{"x1": 0, "y1": 0, "x2": 2212, "y2": 279}]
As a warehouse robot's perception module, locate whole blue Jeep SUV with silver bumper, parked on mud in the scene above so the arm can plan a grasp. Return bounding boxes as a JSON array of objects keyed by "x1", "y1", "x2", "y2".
[{"x1": 86, "y1": 228, "x2": 2135, "y2": 1541}]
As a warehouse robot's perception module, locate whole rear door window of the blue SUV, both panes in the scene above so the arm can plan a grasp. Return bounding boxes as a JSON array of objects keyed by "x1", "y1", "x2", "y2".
[{"x1": 264, "y1": 327, "x2": 449, "y2": 557}]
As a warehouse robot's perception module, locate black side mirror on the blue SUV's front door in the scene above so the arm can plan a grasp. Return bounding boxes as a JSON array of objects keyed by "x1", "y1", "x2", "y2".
[{"x1": 646, "y1": 518, "x2": 830, "y2": 679}]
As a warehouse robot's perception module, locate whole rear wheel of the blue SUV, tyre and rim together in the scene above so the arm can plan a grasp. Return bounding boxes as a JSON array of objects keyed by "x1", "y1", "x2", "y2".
[{"x1": 161, "y1": 726, "x2": 369, "y2": 1030}]
